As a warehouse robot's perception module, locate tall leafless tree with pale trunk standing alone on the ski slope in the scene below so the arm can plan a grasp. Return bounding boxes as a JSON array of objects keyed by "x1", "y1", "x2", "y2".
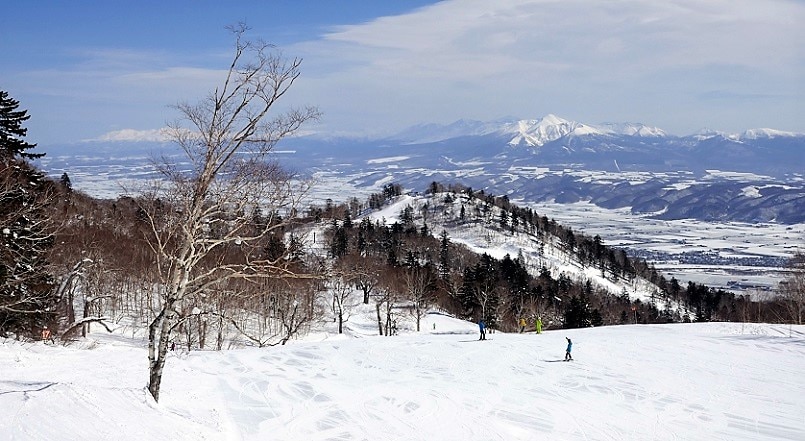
[{"x1": 140, "y1": 25, "x2": 318, "y2": 401}]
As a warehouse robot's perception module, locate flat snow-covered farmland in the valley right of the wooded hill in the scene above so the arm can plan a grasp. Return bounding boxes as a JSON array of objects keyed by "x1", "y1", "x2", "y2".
[{"x1": 528, "y1": 200, "x2": 805, "y2": 294}]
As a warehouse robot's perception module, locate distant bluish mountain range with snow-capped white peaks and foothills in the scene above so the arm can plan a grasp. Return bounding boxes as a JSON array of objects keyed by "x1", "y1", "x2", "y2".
[{"x1": 272, "y1": 115, "x2": 805, "y2": 224}]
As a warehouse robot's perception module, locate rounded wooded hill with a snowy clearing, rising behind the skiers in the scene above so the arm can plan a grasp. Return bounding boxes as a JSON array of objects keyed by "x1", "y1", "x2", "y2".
[{"x1": 318, "y1": 182, "x2": 796, "y2": 330}]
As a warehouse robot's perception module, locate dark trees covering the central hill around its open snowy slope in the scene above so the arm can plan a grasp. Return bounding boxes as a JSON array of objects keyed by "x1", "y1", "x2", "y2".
[{"x1": 320, "y1": 182, "x2": 801, "y2": 333}]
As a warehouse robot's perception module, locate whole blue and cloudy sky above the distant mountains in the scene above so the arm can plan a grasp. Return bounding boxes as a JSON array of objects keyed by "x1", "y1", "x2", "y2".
[{"x1": 0, "y1": 0, "x2": 805, "y2": 146}]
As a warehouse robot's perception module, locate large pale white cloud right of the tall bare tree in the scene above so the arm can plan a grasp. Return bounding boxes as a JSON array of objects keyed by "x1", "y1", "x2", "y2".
[{"x1": 293, "y1": 0, "x2": 805, "y2": 133}]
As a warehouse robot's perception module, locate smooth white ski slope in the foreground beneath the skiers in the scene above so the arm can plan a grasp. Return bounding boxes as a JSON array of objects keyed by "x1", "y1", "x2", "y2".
[{"x1": 0, "y1": 314, "x2": 805, "y2": 441}]
